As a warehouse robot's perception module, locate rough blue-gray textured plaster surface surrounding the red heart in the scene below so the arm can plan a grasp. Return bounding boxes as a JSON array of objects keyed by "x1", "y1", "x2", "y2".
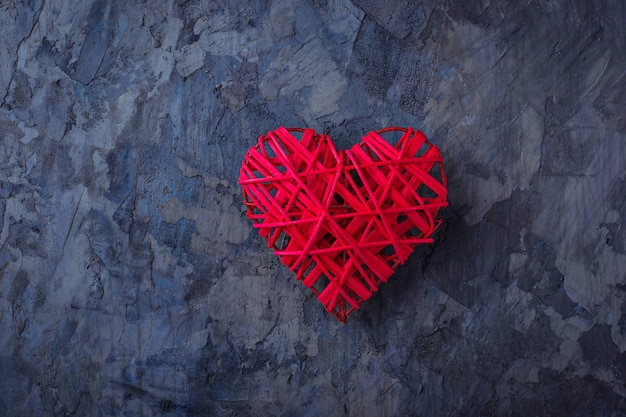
[{"x1": 0, "y1": 0, "x2": 626, "y2": 417}]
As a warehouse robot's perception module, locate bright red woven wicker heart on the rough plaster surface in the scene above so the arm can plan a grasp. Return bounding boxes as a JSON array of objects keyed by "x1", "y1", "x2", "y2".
[{"x1": 239, "y1": 127, "x2": 448, "y2": 323}]
